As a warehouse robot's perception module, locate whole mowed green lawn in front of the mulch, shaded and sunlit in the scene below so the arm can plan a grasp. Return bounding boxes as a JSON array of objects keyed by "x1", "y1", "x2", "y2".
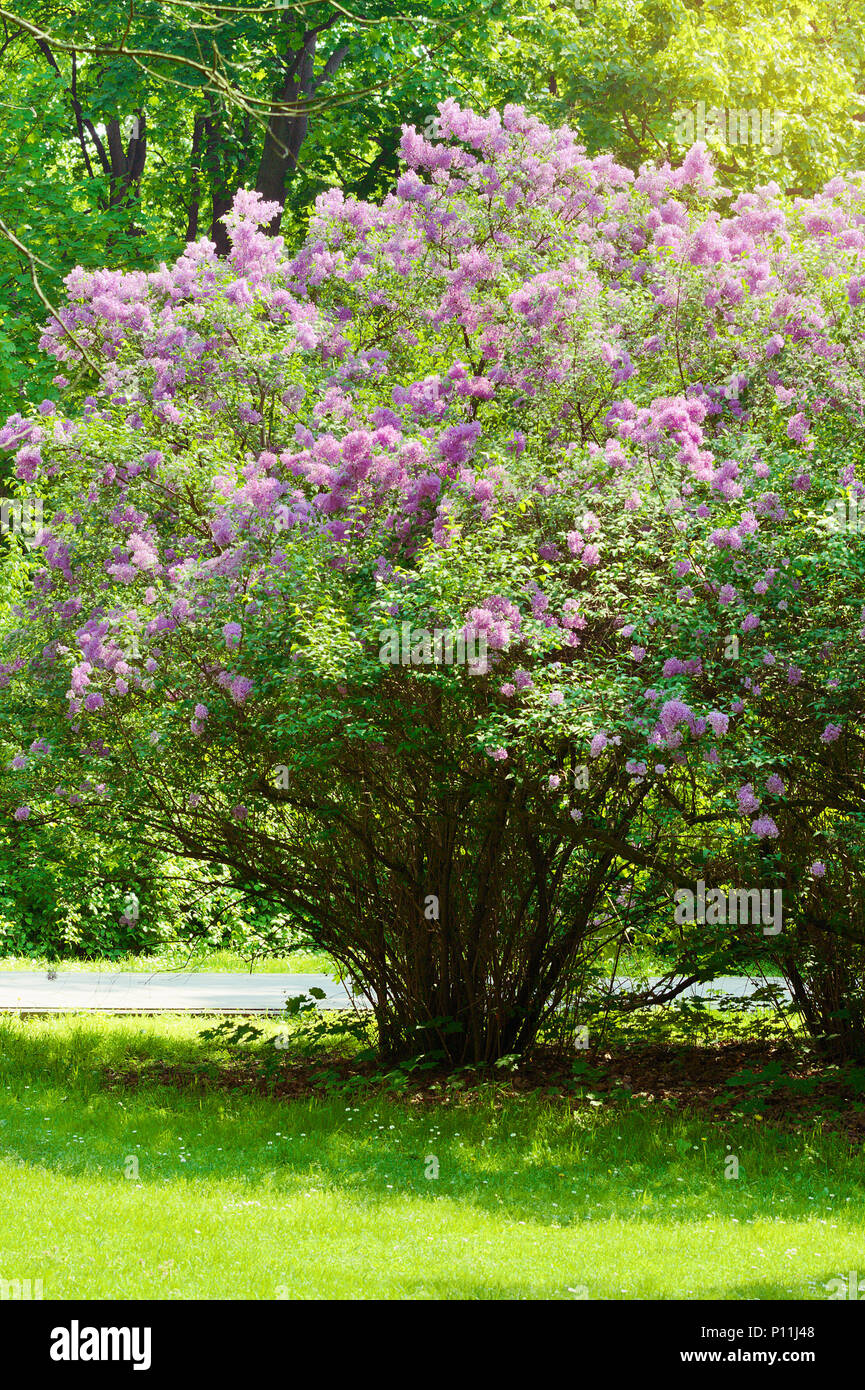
[{"x1": 0, "y1": 1016, "x2": 865, "y2": 1300}]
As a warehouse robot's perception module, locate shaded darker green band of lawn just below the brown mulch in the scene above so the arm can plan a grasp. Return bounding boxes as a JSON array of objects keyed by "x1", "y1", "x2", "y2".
[{"x1": 0, "y1": 1019, "x2": 865, "y2": 1239}]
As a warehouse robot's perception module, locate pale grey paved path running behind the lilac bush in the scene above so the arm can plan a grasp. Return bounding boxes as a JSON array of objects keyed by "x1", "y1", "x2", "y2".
[{"x1": 0, "y1": 969, "x2": 787, "y2": 1013}]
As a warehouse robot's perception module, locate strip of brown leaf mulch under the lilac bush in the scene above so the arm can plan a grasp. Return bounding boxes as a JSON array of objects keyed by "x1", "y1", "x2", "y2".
[{"x1": 103, "y1": 1043, "x2": 865, "y2": 1143}]
